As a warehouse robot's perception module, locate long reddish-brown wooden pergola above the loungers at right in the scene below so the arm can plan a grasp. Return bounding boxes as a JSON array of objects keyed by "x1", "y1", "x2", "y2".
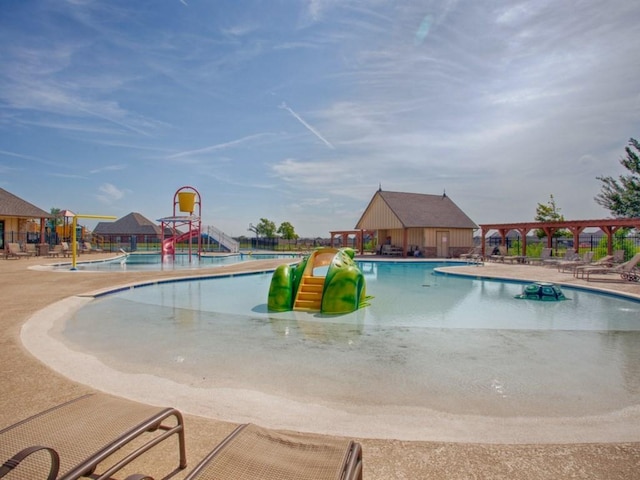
[{"x1": 480, "y1": 218, "x2": 640, "y2": 256}]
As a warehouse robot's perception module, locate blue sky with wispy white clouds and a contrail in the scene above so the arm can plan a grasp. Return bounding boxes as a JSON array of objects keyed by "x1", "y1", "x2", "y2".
[{"x1": 0, "y1": 0, "x2": 640, "y2": 237}]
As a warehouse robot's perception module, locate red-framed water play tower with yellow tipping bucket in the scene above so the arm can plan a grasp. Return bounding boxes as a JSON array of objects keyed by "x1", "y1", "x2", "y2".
[{"x1": 158, "y1": 186, "x2": 202, "y2": 262}]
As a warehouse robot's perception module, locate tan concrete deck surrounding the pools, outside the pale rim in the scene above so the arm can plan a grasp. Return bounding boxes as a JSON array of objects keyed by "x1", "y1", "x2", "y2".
[{"x1": 0, "y1": 254, "x2": 640, "y2": 479}]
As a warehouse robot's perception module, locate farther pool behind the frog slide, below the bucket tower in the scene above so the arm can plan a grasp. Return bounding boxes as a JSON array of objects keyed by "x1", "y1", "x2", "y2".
[{"x1": 56, "y1": 253, "x2": 300, "y2": 272}]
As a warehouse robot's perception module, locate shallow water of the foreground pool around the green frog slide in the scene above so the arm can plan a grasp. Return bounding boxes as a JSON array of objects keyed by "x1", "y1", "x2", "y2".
[{"x1": 63, "y1": 262, "x2": 640, "y2": 417}]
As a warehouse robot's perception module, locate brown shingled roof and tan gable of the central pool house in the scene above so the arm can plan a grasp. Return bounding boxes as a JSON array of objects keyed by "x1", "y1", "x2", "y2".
[{"x1": 356, "y1": 190, "x2": 478, "y2": 230}]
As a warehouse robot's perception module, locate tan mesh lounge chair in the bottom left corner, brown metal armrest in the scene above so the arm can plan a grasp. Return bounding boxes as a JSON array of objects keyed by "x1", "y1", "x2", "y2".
[{"x1": 0, "y1": 394, "x2": 187, "y2": 480}]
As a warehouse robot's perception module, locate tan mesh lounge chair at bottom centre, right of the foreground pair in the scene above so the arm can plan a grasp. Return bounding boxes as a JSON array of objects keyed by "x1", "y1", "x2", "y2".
[{"x1": 127, "y1": 424, "x2": 362, "y2": 480}]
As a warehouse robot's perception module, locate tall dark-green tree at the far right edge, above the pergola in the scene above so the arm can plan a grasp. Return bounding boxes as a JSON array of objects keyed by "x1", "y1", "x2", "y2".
[{"x1": 595, "y1": 138, "x2": 640, "y2": 218}]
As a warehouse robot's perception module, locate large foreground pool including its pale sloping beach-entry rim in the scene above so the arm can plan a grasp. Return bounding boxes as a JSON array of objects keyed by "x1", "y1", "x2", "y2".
[{"x1": 20, "y1": 262, "x2": 640, "y2": 442}]
